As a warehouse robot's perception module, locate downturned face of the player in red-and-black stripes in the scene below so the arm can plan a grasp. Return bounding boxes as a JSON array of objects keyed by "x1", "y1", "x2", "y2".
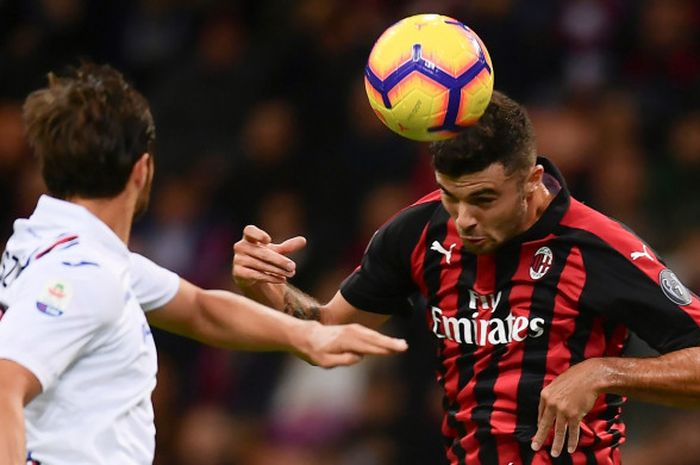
[{"x1": 435, "y1": 163, "x2": 544, "y2": 255}]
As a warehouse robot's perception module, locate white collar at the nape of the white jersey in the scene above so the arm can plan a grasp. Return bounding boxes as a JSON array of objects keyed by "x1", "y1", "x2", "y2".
[{"x1": 29, "y1": 195, "x2": 129, "y2": 257}]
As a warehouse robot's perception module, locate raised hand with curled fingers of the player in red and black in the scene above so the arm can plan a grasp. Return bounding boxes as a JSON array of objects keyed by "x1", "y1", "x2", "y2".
[{"x1": 232, "y1": 225, "x2": 306, "y2": 289}]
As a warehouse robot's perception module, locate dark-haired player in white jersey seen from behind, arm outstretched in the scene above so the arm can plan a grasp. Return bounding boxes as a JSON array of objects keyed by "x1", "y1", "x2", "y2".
[{"x1": 0, "y1": 64, "x2": 406, "y2": 465}]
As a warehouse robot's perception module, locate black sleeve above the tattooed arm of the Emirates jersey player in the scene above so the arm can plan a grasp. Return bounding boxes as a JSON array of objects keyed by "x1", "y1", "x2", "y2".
[{"x1": 340, "y1": 203, "x2": 435, "y2": 314}]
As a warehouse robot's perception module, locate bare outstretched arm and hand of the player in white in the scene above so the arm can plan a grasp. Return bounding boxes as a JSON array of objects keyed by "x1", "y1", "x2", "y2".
[{"x1": 148, "y1": 280, "x2": 407, "y2": 368}]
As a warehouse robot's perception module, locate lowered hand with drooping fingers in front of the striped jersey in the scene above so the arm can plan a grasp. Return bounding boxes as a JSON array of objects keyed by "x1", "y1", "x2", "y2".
[{"x1": 532, "y1": 358, "x2": 601, "y2": 457}]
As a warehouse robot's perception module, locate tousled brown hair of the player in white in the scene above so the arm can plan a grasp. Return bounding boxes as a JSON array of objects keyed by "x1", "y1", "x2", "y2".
[{"x1": 23, "y1": 63, "x2": 155, "y2": 198}]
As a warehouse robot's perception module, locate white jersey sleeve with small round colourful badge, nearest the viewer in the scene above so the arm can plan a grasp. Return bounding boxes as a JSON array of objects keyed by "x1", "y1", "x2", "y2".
[{"x1": 0, "y1": 263, "x2": 125, "y2": 391}]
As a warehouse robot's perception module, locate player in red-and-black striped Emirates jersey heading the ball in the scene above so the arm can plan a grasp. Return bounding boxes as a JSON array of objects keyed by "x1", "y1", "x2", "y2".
[{"x1": 234, "y1": 92, "x2": 700, "y2": 465}]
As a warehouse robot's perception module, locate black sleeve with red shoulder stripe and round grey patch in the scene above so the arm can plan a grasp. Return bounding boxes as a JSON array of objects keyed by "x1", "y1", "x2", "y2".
[{"x1": 581, "y1": 240, "x2": 700, "y2": 353}]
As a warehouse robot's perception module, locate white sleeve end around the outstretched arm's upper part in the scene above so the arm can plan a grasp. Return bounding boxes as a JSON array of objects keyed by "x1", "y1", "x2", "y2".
[{"x1": 130, "y1": 253, "x2": 180, "y2": 312}]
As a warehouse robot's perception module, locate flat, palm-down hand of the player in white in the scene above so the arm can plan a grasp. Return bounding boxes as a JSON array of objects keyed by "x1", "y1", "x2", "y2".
[{"x1": 296, "y1": 321, "x2": 408, "y2": 368}]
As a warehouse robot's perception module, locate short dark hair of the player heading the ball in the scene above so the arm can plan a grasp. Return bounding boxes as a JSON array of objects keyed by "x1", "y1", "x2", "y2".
[{"x1": 430, "y1": 91, "x2": 537, "y2": 178}]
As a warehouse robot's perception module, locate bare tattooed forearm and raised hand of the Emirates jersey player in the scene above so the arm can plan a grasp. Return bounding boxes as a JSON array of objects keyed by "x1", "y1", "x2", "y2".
[{"x1": 233, "y1": 225, "x2": 389, "y2": 329}]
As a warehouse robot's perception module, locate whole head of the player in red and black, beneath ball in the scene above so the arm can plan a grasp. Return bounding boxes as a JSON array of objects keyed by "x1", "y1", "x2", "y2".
[{"x1": 430, "y1": 91, "x2": 543, "y2": 254}]
